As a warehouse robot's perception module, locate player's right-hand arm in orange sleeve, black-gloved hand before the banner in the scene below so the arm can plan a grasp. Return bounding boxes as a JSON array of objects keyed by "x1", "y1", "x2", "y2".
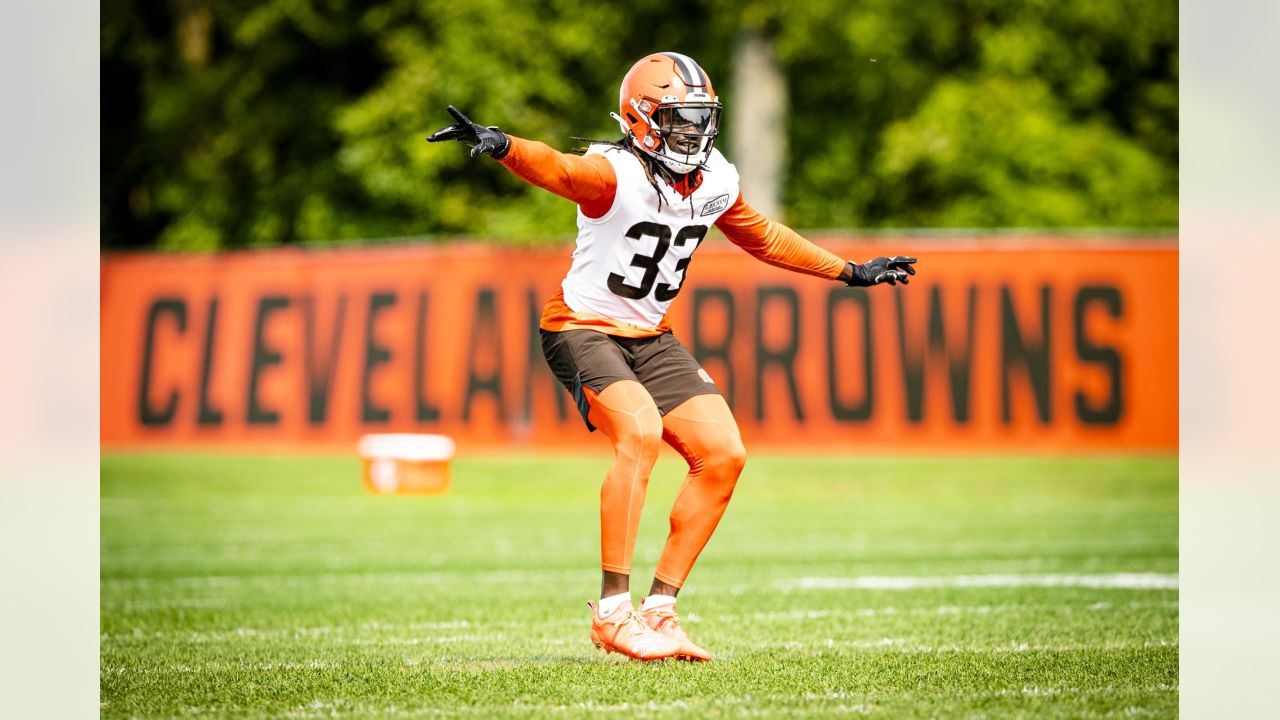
[{"x1": 716, "y1": 195, "x2": 915, "y2": 287}]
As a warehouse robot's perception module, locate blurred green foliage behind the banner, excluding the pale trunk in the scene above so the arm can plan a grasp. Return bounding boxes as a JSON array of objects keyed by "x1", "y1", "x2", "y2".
[{"x1": 101, "y1": 0, "x2": 1178, "y2": 250}]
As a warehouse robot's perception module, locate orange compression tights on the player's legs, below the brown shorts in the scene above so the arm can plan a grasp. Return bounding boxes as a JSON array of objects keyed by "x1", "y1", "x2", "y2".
[{"x1": 588, "y1": 380, "x2": 746, "y2": 587}]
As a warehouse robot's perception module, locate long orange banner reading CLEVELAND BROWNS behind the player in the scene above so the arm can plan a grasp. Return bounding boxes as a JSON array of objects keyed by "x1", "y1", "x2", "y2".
[{"x1": 101, "y1": 238, "x2": 1178, "y2": 451}]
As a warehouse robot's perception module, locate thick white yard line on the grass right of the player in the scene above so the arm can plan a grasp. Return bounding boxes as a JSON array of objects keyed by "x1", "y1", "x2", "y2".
[{"x1": 774, "y1": 573, "x2": 1178, "y2": 591}]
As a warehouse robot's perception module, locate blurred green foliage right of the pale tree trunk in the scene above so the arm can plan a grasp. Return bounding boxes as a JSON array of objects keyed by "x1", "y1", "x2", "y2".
[{"x1": 721, "y1": 0, "x2": 1178, "y2": 228}]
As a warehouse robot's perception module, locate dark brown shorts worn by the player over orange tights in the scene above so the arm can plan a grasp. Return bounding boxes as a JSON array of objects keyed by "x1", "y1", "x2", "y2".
[{"x1": 540, "y1": 331, "x2": 719, "y2": 430}]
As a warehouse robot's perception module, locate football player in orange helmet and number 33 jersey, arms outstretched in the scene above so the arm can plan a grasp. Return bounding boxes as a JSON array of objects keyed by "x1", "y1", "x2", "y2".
[{"x1": 428, "y1": 53, "x2": 915, "y2": 661}]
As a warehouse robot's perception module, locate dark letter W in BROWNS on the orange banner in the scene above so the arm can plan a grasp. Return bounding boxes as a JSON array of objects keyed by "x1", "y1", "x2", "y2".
[{"x1": 893, "y1": 286, "x2": 978, "y2": 424}]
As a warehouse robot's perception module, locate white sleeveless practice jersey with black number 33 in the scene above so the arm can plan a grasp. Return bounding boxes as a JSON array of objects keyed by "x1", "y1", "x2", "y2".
[{"x1": 561, "y1": 145, "x2": 739, "y2": 328}]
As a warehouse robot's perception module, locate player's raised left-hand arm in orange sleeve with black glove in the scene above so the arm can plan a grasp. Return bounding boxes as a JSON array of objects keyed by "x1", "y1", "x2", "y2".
[{"x1": 426, "y1": 105, "x2": 617, "y2": 218}]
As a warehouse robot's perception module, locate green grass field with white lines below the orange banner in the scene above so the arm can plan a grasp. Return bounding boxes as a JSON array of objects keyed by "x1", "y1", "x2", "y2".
[{"x1": 101, "y1": 455, "x2": 1178, "y2": 719}]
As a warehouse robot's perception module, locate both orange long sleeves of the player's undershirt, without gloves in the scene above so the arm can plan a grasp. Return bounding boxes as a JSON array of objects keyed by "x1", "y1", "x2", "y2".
[{"x1": 498, "y1": 135, "x2": 845, "y2": 279}]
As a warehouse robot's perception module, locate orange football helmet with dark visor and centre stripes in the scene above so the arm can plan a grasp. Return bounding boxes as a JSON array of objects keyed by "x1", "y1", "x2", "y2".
[{"x1": 609, "y1": 53, "x2": 721, "y2": 173}]
